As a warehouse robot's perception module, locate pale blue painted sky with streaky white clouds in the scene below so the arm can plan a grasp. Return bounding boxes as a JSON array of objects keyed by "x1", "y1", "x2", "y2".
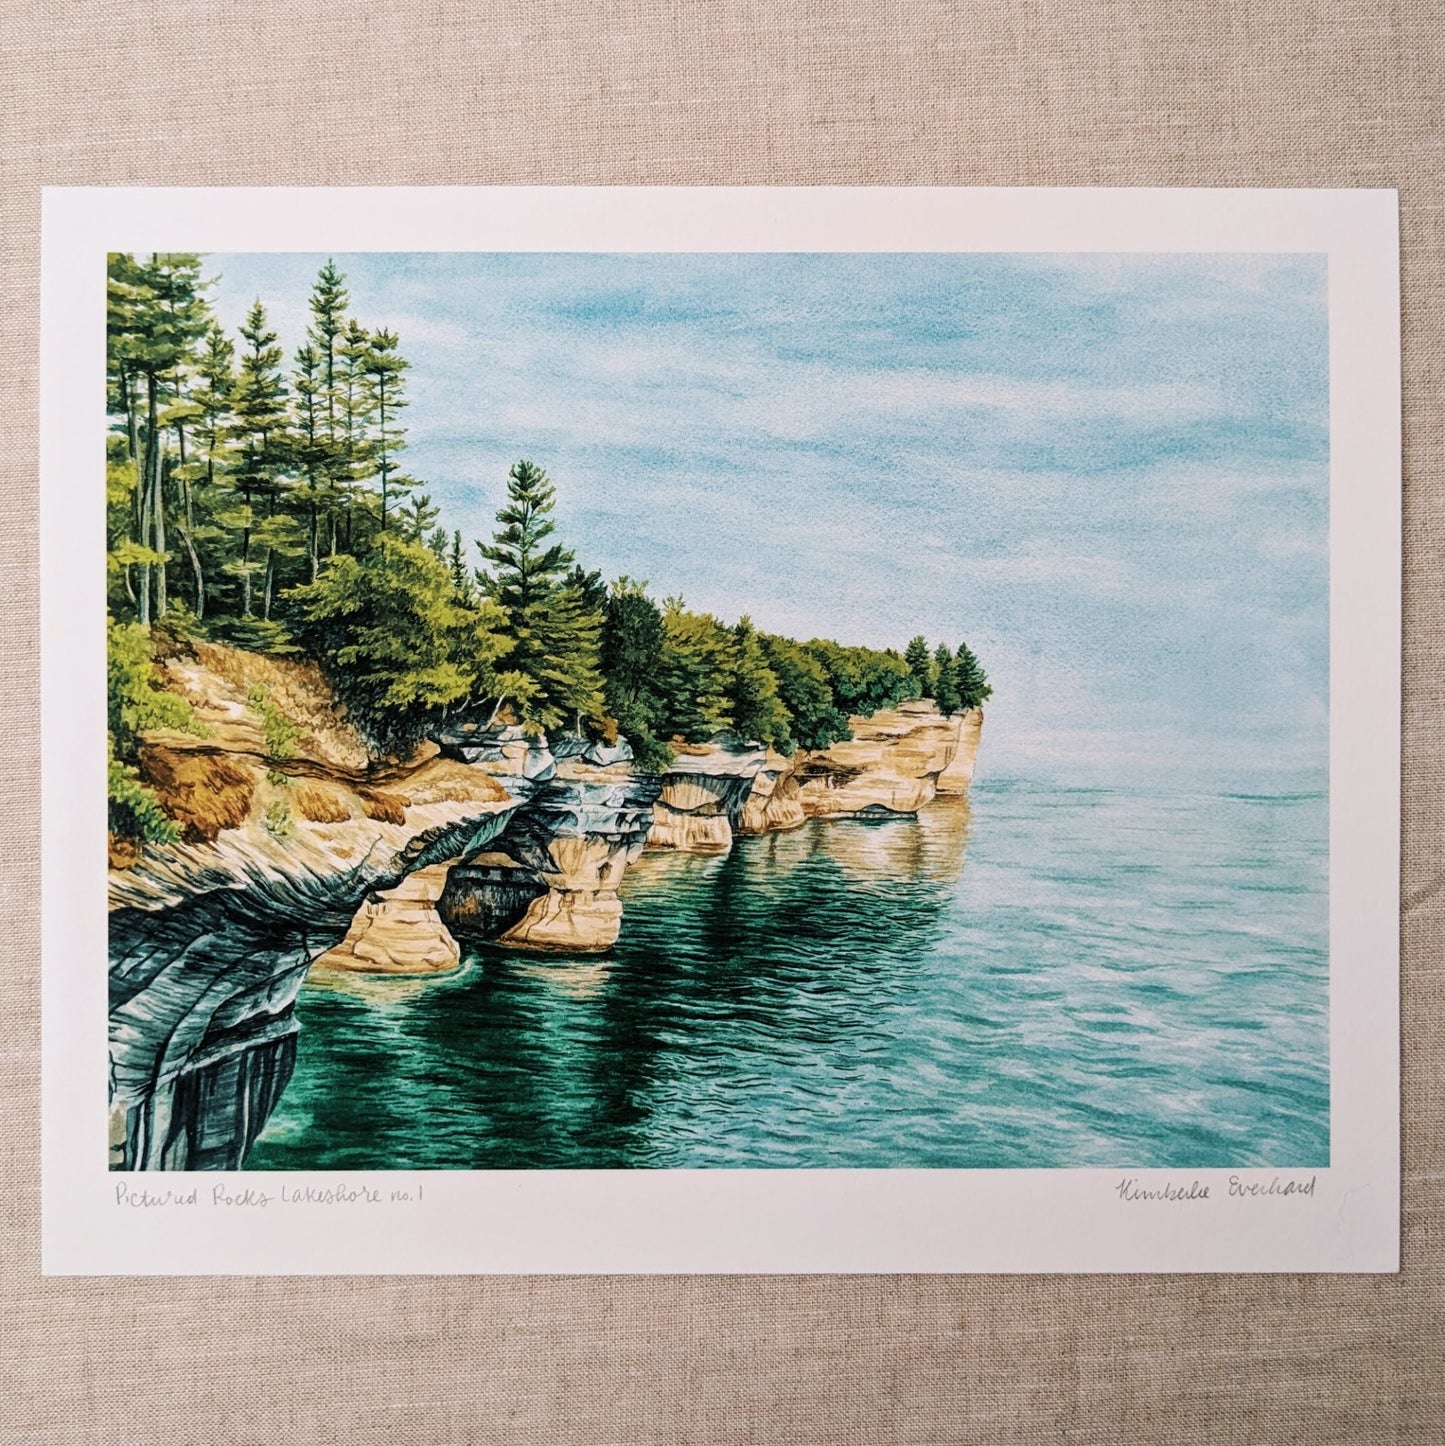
[{"x1": 205, "y1": 253, "x2": 1329, "y2": 785}]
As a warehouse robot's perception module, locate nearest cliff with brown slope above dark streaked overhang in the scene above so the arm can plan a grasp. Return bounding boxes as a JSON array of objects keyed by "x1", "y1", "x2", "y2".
[{"x1": 110, "y1": 645, "x2": 521, "y2": 1170}]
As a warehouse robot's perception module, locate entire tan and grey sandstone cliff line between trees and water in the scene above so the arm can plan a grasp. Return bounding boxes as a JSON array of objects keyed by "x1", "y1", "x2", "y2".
[{"x1": 110, "y1": 643, "x2": 982, "y2": 1168}]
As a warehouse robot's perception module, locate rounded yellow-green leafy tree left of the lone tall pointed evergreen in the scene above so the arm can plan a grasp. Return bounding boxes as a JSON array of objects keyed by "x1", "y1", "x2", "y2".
[{"x1": 291, "y1": 535, "x2": 514, "y2": 750}]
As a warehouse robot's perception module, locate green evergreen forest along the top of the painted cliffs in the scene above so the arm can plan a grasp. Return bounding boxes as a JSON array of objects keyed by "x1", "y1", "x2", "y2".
[{"x1": 106, "y1": 253, "x2": 991, "y2": 837}]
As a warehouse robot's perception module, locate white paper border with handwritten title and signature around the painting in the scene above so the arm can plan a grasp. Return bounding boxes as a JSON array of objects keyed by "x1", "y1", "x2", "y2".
[{"x1": 41, "y1": 188, "x2": 1400, "y2": 1274}]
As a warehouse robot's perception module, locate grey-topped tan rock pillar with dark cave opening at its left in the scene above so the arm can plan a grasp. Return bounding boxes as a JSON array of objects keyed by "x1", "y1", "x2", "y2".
[{"x1": 437, "y1": 755, "x2": 662, "y2": 953}]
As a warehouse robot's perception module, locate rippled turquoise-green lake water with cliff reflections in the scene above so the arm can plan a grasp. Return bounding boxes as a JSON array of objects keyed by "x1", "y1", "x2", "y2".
[{"x1": 247, "y1": 781, "x2": 1329, "y2": 1170}]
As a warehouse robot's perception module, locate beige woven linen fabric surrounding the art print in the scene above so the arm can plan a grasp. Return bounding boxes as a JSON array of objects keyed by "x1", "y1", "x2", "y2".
[{"x1": 0, "y1": 0, "x2": 1445, "y2": 1446}]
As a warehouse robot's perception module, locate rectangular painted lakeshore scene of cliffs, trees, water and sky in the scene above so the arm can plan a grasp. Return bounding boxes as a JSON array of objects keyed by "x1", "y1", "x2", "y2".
[{"x1": 107, "y1": 252, "x2": 1331, "y2": 1171}]
